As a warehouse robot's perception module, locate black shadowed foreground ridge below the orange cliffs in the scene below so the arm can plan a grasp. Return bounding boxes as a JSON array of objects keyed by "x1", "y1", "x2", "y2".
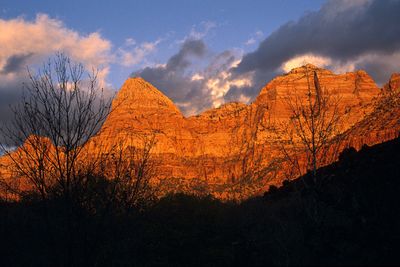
[{"x1": 0, "y1": 138, "x2": 400, "y2": 266}]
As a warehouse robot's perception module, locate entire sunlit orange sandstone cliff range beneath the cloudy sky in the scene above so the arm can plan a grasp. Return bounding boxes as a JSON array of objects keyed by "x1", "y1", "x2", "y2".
[{"x1": 0, "y1": 65, "x2": 400, "y2": 198}]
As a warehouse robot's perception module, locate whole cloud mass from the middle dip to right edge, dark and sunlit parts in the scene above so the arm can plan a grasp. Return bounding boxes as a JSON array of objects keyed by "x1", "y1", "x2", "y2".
[{"x1": 134, "y1": 0, "x2": 400, "y2": 115}]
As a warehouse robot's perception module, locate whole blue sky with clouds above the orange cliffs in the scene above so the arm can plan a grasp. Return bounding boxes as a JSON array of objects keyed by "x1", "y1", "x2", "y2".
[{"x1": 0, "y1": 0, "x2": 400, "y2": 117}]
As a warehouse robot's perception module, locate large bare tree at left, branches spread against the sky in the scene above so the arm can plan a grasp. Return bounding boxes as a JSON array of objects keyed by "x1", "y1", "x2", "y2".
[{"x1": 1, "y1": 53, "x2": 111, "y2": 201}]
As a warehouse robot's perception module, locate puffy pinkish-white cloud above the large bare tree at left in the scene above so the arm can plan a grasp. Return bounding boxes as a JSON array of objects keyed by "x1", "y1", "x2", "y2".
[{"x1": 0, "y1": 14, "x2": 113, "y2": 86}]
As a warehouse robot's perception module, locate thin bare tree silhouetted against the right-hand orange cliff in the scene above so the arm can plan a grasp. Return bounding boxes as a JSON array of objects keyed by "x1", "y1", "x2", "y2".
[{"x1": 281, "y1": 66, "x2": 341, "y2": 182}]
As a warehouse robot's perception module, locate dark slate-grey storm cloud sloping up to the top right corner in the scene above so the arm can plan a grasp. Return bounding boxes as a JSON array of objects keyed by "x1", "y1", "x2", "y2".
[{"x1": 235, "y1": 0, "x2": 400, "y2": 73}]
